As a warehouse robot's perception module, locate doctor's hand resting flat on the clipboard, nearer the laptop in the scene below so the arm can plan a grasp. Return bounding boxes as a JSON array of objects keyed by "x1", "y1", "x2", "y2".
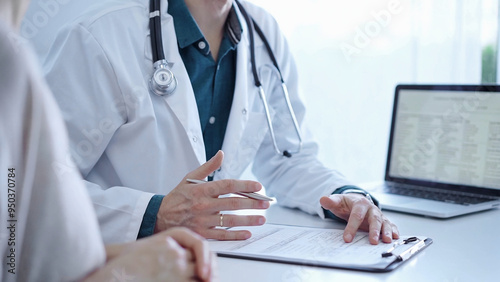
[{"x1": 320, "y1": 193, "x2": 399, "y2": 245}]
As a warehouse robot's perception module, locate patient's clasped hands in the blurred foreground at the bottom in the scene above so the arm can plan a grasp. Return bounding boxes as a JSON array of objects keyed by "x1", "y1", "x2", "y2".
[{"x1": 85, "y1": 228, "x2": 216, "y2": 281}]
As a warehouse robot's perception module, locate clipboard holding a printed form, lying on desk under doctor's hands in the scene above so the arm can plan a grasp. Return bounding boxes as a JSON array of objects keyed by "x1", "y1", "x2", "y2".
[{"x1": 209, "y1": 224, "x2": 432, "y2": 272}]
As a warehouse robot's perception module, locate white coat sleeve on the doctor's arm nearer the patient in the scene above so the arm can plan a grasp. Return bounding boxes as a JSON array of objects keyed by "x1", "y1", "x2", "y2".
[{"x1": 44, "y1": 23, "x2": 153, "y2": 243}]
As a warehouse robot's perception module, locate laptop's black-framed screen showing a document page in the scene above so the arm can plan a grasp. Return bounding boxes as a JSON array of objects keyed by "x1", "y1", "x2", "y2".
[{"x1": 386, "y1": 85, "x2": 500, "y2": 190}]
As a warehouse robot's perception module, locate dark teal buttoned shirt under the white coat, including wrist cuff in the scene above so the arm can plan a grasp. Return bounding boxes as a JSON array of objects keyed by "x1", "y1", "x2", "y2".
[{"x1": 138, "y1": 0, "x2": 242, "y2": 238}]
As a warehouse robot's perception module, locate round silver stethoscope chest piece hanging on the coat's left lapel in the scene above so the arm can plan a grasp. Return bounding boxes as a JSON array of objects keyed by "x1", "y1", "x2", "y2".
[{"x1": 149, "y1": 60, "x2": 177, "y2": 96}]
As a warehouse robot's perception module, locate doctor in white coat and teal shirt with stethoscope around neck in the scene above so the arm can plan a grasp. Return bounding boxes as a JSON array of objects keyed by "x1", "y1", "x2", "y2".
[{"x1": 35, "y1": 0, "x2": 398, "y2": 244}]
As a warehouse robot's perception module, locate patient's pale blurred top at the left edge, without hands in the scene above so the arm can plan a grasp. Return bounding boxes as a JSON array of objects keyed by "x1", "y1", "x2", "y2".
[{"x1": 0, "y1": 22, "x2": 105, "y2": 281}]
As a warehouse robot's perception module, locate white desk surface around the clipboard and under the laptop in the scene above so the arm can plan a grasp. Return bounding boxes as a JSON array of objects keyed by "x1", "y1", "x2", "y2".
[{"x1": 218, "y1": 205, "x2": 500, "y2": 282}]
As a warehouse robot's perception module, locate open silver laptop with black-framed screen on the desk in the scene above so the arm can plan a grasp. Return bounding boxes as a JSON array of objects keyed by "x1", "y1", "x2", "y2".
[{"x1": 370, "y1": 85, "x2": 500, "y2": 218}]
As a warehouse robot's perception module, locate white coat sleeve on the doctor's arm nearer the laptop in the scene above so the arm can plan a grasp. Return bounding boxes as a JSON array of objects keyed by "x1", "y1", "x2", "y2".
[{"x1": 249, "y1": 5, "x2": 351, "y2": 218}]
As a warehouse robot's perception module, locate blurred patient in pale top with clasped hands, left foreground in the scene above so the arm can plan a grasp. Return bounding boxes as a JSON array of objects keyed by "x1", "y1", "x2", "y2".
[{"x1": 0, "y1": 0, "x2": 215, "y2": 281}]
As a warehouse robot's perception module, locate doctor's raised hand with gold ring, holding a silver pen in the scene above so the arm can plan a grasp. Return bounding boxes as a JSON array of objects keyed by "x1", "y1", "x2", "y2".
[{"x1": 155, "y1": 151, "x2": 270, "y2": 240}]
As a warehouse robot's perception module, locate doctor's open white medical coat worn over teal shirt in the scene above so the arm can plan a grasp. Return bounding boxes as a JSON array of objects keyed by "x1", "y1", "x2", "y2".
[{"x1": 42, "y1": 0, "x2": 348, "y2": 243}]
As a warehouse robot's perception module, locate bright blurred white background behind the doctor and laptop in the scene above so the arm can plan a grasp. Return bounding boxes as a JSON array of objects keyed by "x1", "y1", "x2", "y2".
[{"x1": 21, "y1": 0, "x2": 500, "y2": 183}]
